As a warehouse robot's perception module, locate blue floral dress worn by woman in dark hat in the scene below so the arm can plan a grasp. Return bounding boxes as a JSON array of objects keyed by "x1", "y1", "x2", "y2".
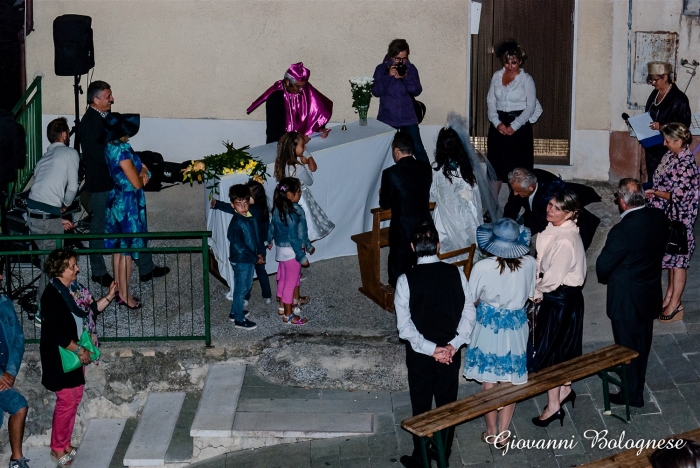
[{"x1": 105, "y1": 142, "x2": 148, "y2": 258}]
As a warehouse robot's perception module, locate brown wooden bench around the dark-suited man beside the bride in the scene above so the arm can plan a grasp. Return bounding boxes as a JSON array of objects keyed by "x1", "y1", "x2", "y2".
[{"x1": 350, "y1": 203, "x2": 476, "y2": 312}]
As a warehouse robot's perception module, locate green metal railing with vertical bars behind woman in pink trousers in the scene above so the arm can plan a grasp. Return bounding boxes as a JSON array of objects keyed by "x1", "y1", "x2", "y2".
[{"x1": 0, "y1": 231, "x2": 211, "y2": 346}]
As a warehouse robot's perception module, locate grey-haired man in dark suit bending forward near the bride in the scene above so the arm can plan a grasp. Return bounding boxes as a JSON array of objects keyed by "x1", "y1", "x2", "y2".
[{"x1": 503, "y1": 167, "x2": 600, "y2": 249}]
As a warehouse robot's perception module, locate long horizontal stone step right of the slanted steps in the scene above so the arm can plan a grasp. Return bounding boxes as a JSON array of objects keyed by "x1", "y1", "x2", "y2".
[{"x1": 232, "y1": 412, "x2": 374, "y2": 439}]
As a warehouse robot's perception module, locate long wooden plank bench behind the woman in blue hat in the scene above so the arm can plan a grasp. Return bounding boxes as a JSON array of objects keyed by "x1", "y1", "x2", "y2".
[{"x1": 401, "y1": 345, "x2": 639, "y2": 468}]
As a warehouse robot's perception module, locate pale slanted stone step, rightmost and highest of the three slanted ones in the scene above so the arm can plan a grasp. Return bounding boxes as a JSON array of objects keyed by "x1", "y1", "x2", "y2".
[{"x1": 190, "y1": 364, "x2": 246, "y2": 437}]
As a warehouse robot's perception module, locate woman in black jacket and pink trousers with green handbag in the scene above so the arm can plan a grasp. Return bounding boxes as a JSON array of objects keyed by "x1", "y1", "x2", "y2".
[{"x1": 39, "y1": 249, "x2": 117, "y2": 467}]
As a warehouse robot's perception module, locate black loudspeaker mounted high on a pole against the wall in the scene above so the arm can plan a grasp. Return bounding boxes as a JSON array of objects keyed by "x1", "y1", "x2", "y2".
[{"x1": 53, "y1": 15, "x2": 95, "y2": 76}]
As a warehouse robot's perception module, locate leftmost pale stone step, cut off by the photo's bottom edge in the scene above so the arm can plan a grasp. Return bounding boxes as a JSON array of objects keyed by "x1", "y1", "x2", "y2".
[{"x1": 71, "y1": 419, "x2": 126, "y2": 468}]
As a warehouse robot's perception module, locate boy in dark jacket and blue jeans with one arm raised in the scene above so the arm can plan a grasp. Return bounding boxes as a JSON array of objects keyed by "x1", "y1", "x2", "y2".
[{"x1": 211, "y1": 184, "x2": 265, "y2": 330}]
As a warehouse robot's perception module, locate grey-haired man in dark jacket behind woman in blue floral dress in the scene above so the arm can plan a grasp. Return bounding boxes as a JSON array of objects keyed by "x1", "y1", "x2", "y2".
[{"x1": 78, "y1": 81, "x2": 170, "y2": 287}]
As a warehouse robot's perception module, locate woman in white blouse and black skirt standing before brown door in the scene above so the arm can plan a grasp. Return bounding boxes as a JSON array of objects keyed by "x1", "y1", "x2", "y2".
[{"x1": 486, "y1": 40, "x2": 542, "y2": 191}]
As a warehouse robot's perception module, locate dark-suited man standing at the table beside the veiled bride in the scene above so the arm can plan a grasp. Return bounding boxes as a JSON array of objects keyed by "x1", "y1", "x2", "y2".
[{"x1": 379, "y1": 132, "x2": 433, "y2": 286}]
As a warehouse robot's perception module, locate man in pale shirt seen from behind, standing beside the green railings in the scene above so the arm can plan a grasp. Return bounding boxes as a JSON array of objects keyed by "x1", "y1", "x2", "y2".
[{"x1": 27, "y1": 117, "x2": 80, "y2": 308}]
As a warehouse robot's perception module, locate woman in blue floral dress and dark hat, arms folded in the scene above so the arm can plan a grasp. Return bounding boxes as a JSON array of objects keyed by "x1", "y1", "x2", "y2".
[{"x1": 104, "y1": 112, "x2": 151, "y2": 309}]
